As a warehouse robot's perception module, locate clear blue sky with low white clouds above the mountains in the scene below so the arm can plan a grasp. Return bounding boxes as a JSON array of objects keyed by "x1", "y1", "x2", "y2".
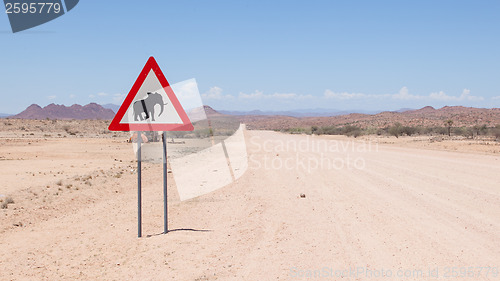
[{"x1": 0, "y1": 0, "x2": 500, "y2": 113}]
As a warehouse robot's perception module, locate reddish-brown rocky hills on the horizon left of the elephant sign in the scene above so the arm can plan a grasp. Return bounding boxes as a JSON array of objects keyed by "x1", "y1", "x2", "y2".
[{"x1": 13, "y1": 103, "x2": 115, "y2": 120}]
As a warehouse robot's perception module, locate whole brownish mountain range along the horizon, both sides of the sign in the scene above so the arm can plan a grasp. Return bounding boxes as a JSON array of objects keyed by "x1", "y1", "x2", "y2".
[{"x1": 4, "y1": 103, "x2": 500, "y2": 130}]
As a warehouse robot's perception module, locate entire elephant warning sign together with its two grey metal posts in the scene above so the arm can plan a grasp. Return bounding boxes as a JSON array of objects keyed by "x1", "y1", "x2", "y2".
[{"x1": 109, "y1": 57, "x2": 194, "y2": 237}]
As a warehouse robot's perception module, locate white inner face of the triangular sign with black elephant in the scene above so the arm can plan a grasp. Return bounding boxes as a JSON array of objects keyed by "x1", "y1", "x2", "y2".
[{"x1": 120, "y1": 70, "x2": 182, "y2": 124}]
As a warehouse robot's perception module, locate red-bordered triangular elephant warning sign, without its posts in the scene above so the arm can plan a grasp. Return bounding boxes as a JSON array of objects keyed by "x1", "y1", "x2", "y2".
[{"x1": 109, "y1": 57, "x2": 193, "y2": 131}]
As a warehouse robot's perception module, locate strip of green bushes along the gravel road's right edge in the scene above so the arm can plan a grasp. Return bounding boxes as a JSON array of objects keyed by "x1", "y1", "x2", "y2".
[{"x1": 281, "y1": 120, "x2": 500, "y2": 141}]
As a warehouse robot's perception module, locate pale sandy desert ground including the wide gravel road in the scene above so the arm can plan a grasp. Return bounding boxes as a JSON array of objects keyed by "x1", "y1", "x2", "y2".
[{"x1": 0, "y1": 120, "x2": 500, "y2": 280}]
